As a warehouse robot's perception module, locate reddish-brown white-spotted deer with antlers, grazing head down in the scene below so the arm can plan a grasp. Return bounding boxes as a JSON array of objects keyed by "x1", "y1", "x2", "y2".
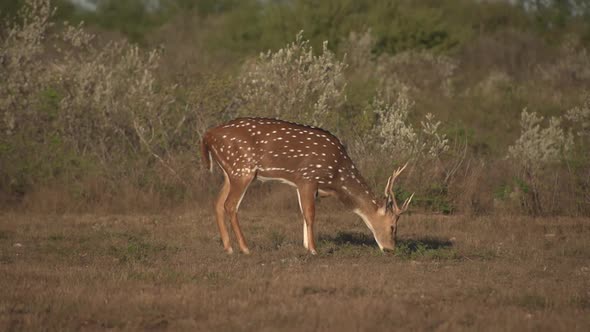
[{"x1": 201, "y1": 118, "x2": 414, "y2": 255}]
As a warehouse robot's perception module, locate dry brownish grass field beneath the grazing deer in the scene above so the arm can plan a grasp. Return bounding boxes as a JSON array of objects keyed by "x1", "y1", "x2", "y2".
[{"x1": 0, "y1": 206, "x2": 590, "y2": 331}]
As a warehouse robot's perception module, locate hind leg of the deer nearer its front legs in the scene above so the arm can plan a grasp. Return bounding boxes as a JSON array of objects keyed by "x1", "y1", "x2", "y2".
[{"x1": 224, "y1": 174, "x2": 255, "y2": 254}]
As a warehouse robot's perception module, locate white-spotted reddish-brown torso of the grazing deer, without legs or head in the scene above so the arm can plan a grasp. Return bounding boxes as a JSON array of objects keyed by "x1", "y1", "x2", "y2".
[{"x1": 204, "y1": 118, "x2": 354, "y2": 184}]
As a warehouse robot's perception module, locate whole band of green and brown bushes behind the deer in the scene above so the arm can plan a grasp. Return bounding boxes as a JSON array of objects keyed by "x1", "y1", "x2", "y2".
[{"x1": 0, "y1": 0, "x2": 590, "y2": 215}]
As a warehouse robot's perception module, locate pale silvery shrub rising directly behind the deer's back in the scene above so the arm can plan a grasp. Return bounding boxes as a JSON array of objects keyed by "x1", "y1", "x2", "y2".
[{"x1": 240, "y1": 32, "x2": 346, "y2": 126}]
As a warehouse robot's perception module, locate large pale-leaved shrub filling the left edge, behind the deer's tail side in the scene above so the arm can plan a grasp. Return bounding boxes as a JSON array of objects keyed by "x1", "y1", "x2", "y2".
[{"x1": 0, "y1": 0, "x2": 198, "y2": 209}]
